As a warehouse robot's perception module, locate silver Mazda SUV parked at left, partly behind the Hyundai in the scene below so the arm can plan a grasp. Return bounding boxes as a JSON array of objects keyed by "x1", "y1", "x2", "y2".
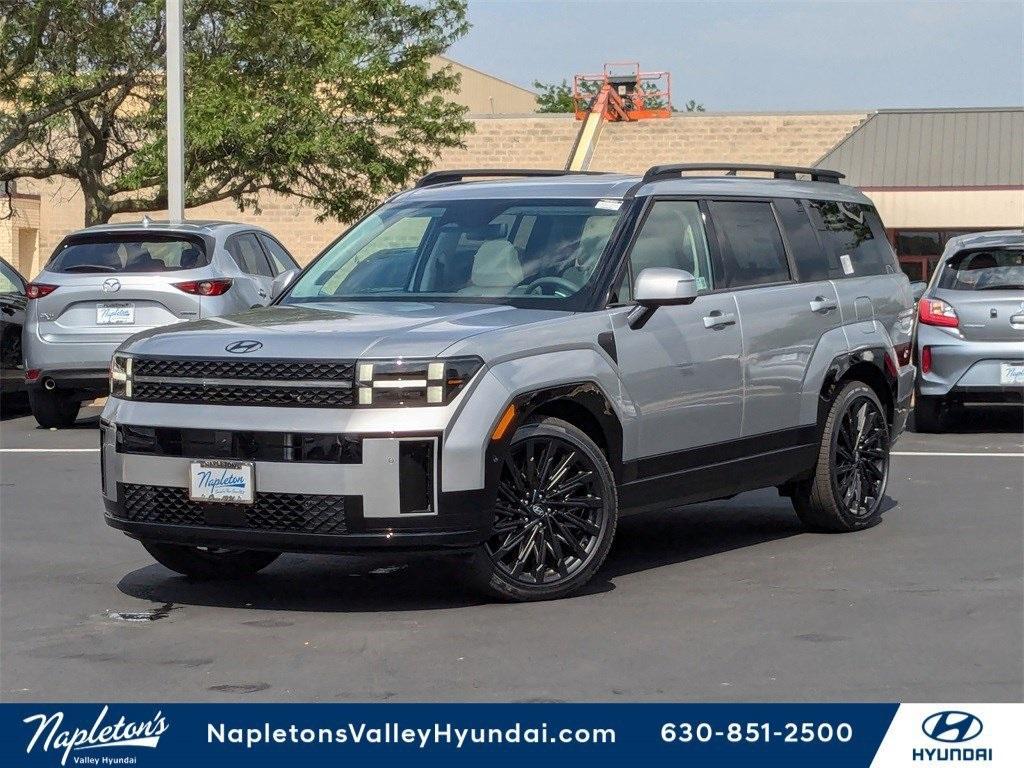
[{"x1": 24, "y1": 220, "x2": 296, "y2": 427}]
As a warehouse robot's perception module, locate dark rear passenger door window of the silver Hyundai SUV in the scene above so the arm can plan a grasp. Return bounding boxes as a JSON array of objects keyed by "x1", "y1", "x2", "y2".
[{"x1": 709, "y1": 201, "x2": 791, "y2": 288}]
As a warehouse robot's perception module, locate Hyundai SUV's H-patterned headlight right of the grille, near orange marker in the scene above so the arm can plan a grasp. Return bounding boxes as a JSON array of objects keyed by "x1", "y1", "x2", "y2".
[{"x1": 355, "y1": 357, "x2": 483, "y2": 408}]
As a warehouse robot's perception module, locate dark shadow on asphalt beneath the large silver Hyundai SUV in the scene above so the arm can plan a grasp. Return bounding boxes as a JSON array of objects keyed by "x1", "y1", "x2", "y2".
[{"x1": 118, "y1": 490, "x2": 864, "y2": 612}]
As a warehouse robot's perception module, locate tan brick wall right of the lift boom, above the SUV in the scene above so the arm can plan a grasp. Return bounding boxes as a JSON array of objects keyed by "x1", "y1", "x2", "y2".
[{"x1": 590, "y1": 112, "x2": 867, "y2": 173}]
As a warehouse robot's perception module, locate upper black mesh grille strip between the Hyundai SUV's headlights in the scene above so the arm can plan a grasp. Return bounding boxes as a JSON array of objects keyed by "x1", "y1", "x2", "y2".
[{"x1": 132, "y1": 357, "x2": 355, "y2": 408}]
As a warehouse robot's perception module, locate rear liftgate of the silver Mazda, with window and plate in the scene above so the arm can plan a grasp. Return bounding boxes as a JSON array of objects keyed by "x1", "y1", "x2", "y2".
[{"x1": 33, "y1": 232, "x2": 203, "y2": 342}]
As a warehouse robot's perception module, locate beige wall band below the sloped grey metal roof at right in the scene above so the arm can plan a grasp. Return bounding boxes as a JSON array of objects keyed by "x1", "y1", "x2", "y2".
[{"x1": 864, "y1": 187, "x2": 1024, "y2": 229}]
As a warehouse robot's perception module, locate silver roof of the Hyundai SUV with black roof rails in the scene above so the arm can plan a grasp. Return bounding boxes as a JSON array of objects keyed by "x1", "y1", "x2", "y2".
[{"x1": 392, "y1": 173, "x2": 871, "y2": 205}]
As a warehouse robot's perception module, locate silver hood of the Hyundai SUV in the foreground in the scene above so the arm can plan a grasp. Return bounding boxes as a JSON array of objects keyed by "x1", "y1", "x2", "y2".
[{"x1": 121, "y1": 301, "x2": 568, "y2": 359}]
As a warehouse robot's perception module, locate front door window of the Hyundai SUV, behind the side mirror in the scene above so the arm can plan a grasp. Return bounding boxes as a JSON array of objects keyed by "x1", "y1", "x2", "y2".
[{"x1": 618, "y1": 200, "x2": 714, "y2": 302}]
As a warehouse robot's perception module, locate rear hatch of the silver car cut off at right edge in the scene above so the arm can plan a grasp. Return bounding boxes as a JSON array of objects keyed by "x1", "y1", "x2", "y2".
[{"x1": 932, "y1": 247, "x2": 1024, "y2": 342}]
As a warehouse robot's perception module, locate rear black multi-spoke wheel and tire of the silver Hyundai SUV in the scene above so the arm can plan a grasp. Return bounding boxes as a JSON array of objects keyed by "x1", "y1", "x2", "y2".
[{"x1": 793, "y1": 381, "x2": 891, "y2": 532}]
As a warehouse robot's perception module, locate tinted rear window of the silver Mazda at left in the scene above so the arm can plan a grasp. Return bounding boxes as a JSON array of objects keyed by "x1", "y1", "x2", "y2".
[{"x1": 46, "y1": 234, "x2": 210, "y2": 273}]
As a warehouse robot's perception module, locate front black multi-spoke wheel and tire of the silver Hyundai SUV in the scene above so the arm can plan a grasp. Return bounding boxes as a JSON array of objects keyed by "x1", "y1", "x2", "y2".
[{"x1": 471, "y1": 418, "x2": 618, "y2": 601}]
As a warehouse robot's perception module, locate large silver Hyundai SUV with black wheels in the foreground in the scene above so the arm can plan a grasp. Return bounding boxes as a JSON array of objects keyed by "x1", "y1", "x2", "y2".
[{"x1": 101, "y1": 165, "x2": 914, "y2": 600}]
